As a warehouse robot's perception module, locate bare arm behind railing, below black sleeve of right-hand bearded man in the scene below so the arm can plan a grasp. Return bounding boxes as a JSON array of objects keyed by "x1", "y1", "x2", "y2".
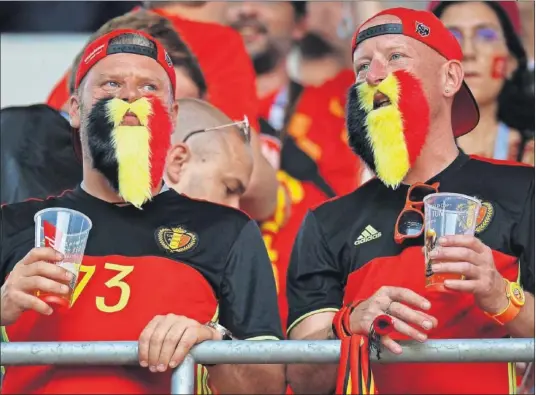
[{"x1": 287, "y1": 328, "x2": 337, "y2": 394}]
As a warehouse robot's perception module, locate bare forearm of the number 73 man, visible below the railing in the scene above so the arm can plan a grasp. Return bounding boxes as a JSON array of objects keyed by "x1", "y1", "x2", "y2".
[{"x1": 208, "y1": 365, "x2": 286, "y2": 394}]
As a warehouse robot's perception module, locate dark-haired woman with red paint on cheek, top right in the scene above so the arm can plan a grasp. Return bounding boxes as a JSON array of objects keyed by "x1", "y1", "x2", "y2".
[{"x1": 430, "y1": 1, "x2": 534, "y2": 164}]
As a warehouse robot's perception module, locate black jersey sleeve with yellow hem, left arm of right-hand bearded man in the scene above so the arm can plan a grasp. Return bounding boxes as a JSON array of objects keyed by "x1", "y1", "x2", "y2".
[{"x1": 287, "y1": 211, "x2": 343, "y2": 333}]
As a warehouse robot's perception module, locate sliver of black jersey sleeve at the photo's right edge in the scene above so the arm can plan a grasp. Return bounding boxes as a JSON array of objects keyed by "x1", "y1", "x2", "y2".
[{"x1": 512, "y1": 173, "x2": 535, "y2": 295}]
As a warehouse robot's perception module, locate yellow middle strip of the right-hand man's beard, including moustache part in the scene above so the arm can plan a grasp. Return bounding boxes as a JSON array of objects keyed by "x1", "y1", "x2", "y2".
[{"x1": 358, "y1": 75, "x2": 410, "y2": 189}]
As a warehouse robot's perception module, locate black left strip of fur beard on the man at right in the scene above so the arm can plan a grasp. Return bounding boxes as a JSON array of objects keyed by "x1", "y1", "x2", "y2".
[{"x1": 346, "y1": 84, "x2": 376, "y2": 172}]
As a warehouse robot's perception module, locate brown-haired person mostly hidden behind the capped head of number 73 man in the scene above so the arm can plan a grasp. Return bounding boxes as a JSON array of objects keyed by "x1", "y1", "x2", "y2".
[{"x1": 47, "y1": 11, "x2": 207, "y2": 112}]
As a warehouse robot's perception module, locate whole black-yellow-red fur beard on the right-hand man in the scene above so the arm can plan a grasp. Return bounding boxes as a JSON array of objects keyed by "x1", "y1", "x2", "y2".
[{"x1": 346, "y1": 71, "x2": 430, "y2": 189}]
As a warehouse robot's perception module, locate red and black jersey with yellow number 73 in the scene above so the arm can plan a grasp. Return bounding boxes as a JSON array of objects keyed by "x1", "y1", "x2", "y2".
[{"x1": 1, "y1": 188, "x2": 282, "y2": 394}]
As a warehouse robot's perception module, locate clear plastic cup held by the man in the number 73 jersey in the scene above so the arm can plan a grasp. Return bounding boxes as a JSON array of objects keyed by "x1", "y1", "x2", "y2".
[{"x1": 34, "y1": 207, "x2": 92, "y2": 308}]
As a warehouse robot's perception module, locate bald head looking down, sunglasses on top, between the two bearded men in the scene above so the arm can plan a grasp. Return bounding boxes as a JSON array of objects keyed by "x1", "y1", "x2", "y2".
[{"x1": 165, "y1": 99, "x2": 253, "y2": 208}]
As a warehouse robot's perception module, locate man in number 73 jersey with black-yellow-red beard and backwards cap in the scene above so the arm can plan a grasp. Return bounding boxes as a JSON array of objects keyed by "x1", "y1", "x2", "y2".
[{"x1": 0, "y1": 30, "x2": 284, "y2": 394}]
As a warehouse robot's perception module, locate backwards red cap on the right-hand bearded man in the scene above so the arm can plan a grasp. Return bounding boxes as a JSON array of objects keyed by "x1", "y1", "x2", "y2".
[{"x1": 352, "y1": 8, "x2": 480, "y2": 137}]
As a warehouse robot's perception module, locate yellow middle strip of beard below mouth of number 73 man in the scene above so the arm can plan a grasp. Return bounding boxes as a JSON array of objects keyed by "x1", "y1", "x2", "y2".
[{"x1": 112, "y1": 126, "x2": 153, "y2": 208}]
